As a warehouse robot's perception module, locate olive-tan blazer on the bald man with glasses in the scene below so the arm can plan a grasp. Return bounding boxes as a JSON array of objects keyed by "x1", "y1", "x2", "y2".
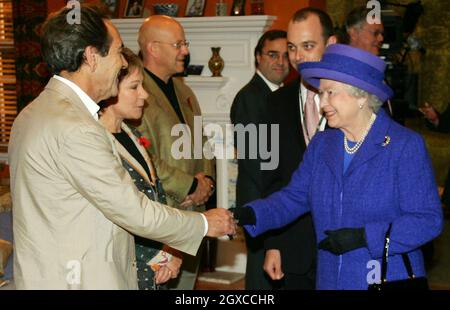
[{"x1": 138, "y1": 73, "x2": 215, "y2": 207}]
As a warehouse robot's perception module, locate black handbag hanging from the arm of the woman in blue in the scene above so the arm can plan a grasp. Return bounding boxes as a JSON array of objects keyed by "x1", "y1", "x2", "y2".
[{"x1": 368, "y1": 224, "x2": 429, "y2": 291}]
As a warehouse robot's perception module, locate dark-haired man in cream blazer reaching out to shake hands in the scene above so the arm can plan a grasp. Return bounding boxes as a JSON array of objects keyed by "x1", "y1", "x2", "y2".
[{"x1": 9, "y1": 7, "x2": 235, "y2": 289}]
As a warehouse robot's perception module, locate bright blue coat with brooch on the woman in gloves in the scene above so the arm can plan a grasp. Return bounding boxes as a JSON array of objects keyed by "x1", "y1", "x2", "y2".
[{"x1": 245, "y1": 111, "x2": 443, "y2": 289}]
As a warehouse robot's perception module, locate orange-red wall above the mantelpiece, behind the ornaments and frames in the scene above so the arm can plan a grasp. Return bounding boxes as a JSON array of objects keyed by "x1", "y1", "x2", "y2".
[{"x1": 47, "y1": 0, "x2": 326, "y2": 29}]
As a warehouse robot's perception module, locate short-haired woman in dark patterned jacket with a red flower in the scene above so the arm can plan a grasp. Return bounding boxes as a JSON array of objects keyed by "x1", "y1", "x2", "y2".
[{"x1": 100, "y1": 48, "x2": 181, "y2": 290}]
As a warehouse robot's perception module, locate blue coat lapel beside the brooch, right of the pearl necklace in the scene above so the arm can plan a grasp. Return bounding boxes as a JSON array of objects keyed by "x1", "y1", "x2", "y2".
[{"x1": 342, "y1": 109, "x2": 390, "y2": 175}]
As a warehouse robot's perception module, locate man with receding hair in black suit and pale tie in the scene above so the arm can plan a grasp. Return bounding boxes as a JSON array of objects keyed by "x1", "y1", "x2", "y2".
[{"x1": 261, "y1": 7, "x2": 336, "y2": 289}]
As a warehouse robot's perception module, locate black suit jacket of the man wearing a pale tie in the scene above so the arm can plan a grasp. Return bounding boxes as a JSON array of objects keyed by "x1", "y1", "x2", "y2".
[{"x1": 262, "y1": 79, "x2": 316, "y2": 274}]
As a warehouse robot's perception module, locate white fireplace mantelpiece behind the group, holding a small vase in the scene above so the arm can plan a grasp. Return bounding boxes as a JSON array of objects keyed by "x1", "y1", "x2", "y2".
[{"x1": 113, "y1": 15, "x2": 276, "y2": 273}]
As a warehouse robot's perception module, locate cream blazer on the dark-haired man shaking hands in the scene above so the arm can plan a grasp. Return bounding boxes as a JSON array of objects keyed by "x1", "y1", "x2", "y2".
[{"x1": 9, "y1": 79, "x2": 204, "y2": 289}]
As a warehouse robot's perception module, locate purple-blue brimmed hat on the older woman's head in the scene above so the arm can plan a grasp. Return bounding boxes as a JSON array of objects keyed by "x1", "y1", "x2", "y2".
[{"x1": 298, "y1": 44, "x2": 394, "y2": 102}]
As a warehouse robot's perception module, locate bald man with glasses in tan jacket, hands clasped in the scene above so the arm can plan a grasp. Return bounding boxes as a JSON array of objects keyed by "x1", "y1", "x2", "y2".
[{"x1": 138, "y1": 15, "x2": 215, "y2": 290}]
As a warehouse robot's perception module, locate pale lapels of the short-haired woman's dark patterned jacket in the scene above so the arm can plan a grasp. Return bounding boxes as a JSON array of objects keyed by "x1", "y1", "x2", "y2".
[{"x1": 113, "y1": 123, "x2": 154, "y2": 185}]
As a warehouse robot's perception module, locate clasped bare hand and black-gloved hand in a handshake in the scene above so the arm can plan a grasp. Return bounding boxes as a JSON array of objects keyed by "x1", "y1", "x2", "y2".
[{"x1": 203, "y1": 207, "x2": 256, "y2": 239}]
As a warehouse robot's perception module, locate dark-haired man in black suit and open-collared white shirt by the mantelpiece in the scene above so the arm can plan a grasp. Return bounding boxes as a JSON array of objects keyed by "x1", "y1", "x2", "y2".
[{"x1": 231, "y1": 30, "x2": 289, "y2": 289}]
